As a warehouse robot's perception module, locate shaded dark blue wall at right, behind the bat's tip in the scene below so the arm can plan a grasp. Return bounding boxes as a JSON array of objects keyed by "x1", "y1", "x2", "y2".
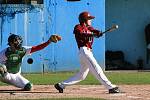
[{"x1": 106, "y1": 0, "x2": 150, "y2": 69}]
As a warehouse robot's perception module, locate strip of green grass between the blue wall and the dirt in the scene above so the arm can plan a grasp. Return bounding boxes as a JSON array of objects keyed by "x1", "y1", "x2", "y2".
[{"x1": 0, "y1": 71, "x2": 150, "y2": 85}]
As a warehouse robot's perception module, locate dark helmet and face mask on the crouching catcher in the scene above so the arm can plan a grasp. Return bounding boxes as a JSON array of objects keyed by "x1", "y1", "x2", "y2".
[{"x1": 8, "y1": 33, "x2": 23, "y2": 48}]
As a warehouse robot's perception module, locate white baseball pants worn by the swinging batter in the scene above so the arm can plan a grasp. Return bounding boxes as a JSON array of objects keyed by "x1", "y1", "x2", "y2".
[{"x1": 59, "y1": 47, "x2": 116, "y2": 89}]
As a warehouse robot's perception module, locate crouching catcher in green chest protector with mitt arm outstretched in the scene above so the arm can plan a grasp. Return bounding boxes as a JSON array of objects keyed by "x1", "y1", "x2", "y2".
[{"x1": 0, "y1": 34, "x2": 61, "y2": 91}]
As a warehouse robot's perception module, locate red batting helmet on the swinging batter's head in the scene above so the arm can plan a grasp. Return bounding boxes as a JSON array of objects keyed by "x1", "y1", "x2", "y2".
[{"x1": 79, "y1": 11, "x2": 95, "y2": 23}]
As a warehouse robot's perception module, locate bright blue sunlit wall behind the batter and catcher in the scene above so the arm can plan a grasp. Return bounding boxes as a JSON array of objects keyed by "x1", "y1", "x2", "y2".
[{"x1": 0, "y1": 0, "x2": 105, "y2": 73}]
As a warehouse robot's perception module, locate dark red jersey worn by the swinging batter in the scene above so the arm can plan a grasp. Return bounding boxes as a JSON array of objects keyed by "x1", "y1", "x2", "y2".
[{"x1": 74, "y1": 24, "x2": 100, "y2": 49}]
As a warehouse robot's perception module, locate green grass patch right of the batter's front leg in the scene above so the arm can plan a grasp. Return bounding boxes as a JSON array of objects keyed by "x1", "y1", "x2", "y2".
[{"x1": 106, "y1": 72, "x2": 150, "y2": 85}]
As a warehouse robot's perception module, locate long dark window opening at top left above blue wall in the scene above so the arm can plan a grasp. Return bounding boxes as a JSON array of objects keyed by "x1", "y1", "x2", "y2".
[{"x1": 0, "y1": 0, "x2": 43, "y2": 4}]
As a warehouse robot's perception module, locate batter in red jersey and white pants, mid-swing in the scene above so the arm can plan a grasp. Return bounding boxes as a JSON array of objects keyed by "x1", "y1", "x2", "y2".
[{"x1": 54, "y1": 11, "x2": 120, "y2": 93}]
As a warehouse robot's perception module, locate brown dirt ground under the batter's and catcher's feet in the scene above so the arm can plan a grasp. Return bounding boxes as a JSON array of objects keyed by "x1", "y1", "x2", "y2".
[{"x1": 0, "y1": 85, "x2": 150, "y2": 100}]
